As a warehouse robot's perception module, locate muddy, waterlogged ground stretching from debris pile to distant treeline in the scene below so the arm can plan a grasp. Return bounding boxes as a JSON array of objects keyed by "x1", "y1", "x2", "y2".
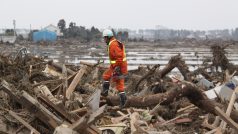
[{"x1": 1, "y1": 39, "x2": 238, "y2": 70}]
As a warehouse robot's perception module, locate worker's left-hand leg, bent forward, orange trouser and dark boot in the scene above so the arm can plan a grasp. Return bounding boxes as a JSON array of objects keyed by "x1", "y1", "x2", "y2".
[{"x1": 101, "y1": 68, "x2": 113, "y2": 96}]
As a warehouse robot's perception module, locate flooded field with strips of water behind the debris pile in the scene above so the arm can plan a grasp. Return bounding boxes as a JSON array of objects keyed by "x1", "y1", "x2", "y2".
[{"x1": 1, "y1": 40, "x2": 238, "y2": 71}]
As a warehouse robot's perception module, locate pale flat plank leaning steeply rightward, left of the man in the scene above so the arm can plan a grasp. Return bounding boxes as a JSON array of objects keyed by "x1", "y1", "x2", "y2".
[{"x1": 66, "y1": 66, "x2": 87, "y2": 99}]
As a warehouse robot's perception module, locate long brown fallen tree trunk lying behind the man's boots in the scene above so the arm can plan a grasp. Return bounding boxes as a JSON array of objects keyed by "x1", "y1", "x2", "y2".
[{"x1": 106, "y1": 83, "x2": 238, "y2": 122}]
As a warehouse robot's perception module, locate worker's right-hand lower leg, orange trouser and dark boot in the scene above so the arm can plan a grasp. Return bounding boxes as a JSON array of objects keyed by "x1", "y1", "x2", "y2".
[{"x1": 116, "y1": 79, "x2": 127, "y2": 108}]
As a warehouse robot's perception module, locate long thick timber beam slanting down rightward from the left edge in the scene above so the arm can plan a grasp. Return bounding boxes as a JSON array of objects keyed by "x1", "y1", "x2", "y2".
[{"x1": 1, "y1": 80, "x2": 63, "y2": 128}]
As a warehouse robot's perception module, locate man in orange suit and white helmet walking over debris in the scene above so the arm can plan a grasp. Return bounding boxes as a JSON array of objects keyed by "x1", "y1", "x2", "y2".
[{"x1": 102, "y1": 29, "x2": 128, "y2": 108}]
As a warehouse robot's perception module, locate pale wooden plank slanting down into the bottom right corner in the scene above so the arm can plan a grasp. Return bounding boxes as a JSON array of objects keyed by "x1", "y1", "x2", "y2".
[{"x1": 215, "y1": 106, "x2": 238, "y2": 132}]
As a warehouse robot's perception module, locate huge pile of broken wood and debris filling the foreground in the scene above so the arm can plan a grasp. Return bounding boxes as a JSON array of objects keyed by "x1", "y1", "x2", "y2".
[{"x1": 0, "y1": 46, "x2": 238, "y2": 134}]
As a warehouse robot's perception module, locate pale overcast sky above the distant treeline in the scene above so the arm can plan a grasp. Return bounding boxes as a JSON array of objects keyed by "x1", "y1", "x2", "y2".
[{"x1": 0, "y1": 0, "x2": 238, "y2": 30}]
